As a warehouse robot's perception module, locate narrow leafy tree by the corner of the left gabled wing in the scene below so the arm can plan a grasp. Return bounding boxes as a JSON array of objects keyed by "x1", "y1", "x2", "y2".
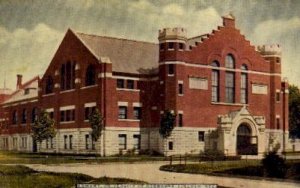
[{"x1": 89, "y1": 108, "x2": 103, "y2": 141}]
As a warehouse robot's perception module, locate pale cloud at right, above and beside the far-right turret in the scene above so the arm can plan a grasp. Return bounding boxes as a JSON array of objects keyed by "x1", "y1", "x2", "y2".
[{"x1": 251, "y1": 17, "x2": 300, "y2": 86}]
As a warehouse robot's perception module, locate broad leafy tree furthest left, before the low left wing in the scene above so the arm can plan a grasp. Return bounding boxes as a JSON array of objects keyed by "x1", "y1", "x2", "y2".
[{"x1": 31, "y1": 110, "x2": 56, "y2": 150}]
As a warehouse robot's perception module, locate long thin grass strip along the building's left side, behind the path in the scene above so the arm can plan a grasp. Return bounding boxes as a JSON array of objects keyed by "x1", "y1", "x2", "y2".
[{"x1": 0, "y1": 151, "x2": 165, "y2": 164}]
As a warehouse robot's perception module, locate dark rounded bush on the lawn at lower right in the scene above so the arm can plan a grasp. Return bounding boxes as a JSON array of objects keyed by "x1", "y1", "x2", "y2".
[{"x1": 262, "y1": 151, "x2": 287, "y2": 178}]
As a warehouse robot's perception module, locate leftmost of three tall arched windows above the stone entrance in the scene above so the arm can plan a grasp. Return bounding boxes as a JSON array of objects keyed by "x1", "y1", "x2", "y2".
[{"x1": 211, "y1": 61, "x2": 220, "y2": 102}]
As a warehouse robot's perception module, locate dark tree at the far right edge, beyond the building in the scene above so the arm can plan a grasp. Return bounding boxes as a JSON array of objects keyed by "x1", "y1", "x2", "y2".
[{"x1": 289, "y1": 85, "x2": 300, "y2": 138}]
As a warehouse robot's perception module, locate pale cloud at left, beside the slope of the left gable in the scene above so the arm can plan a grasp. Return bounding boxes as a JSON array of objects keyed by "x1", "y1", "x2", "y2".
[{"x1": 0, "y1": 23, "x2": 63, "y2": 88}]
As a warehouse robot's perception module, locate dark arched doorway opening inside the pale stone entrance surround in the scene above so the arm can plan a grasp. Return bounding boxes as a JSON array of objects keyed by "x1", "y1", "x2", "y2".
[{"x1": 236, "y1": 123, "x2": 257, "y2": 155}]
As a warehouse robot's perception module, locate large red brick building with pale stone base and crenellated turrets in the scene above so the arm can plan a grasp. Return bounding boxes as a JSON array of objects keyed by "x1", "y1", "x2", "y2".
[{"x1": 0, "y1": 15, "x2": 288, "y2": 155}]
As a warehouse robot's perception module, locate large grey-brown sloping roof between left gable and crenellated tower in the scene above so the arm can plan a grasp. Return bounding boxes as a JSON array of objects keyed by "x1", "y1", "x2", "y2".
[{"x1": 74, "y1": 32, "x2": 159, "y2": 74}]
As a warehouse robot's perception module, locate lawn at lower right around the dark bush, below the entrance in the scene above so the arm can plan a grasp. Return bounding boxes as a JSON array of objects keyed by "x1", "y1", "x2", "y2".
[{"x1": 160, "y1": 160, "x2": 300, "y2": 181}]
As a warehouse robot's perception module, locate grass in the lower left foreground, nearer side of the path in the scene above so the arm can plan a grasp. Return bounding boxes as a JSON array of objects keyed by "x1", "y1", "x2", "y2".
[{"x1": 0, "y1": 165, "x2": 146, "y2": 188}]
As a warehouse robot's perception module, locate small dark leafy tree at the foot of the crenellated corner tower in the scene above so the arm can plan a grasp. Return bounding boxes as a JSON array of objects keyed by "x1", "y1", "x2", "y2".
[{"x1": 159, "y1": 110, "x2": 176, "y2": 138}]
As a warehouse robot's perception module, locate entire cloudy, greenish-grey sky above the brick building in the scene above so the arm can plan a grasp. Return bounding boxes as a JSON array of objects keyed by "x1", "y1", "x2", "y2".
[{"x1": 0, "y1": 0, "x2": 300, "y2": 89}]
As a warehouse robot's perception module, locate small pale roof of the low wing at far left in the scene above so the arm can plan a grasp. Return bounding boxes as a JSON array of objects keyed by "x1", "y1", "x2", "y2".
[{"x1": 2, "y1": 76, "x2": 39, "y2": 104}]
